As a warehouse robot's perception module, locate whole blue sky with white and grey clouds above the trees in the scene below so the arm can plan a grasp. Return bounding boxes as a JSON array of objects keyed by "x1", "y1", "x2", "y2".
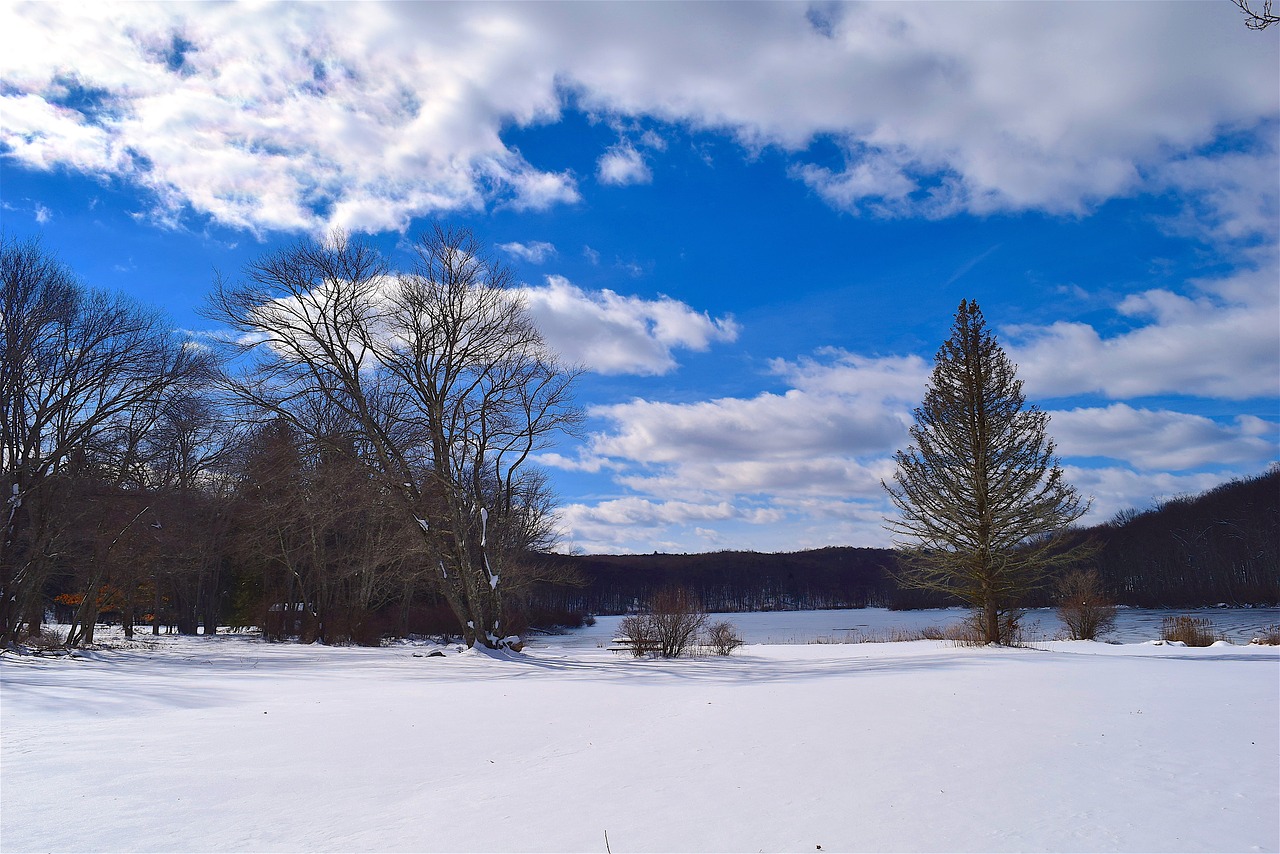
[{"x1": 0, "y1": 0, "x2": 1280, "y2": 552}]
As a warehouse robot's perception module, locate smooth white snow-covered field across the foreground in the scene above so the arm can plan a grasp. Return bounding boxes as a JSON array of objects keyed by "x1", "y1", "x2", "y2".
[{"x1": 0, "y1": 612, "x2": 1280, "y2": 854}]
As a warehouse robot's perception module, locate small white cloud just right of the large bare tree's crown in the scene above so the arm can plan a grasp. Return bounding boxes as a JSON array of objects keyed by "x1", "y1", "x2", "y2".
[{"x1": 522, "y1": 275, "x2": 739, "y2": 375}]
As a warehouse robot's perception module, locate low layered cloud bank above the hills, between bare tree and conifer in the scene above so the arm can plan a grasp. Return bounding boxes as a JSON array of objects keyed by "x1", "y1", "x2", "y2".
[{"x1": 544, "y1": 350, "x2": 928, "y2": 551}]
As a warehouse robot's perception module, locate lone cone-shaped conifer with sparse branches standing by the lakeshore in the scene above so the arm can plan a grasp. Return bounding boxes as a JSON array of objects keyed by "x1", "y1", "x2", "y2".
[{"x1": 883, "y1": 301, "x2": 1088, "y2": 643}]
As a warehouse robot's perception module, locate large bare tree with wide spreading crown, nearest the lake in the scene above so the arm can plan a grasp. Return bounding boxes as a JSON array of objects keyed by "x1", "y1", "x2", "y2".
[{"x1": 210, "y1": 227, "x2": 579, "y2": 647}]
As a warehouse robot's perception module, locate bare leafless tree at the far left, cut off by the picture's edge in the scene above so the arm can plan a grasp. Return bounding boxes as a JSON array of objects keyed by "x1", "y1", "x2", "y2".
[{"x1": 0, "y1": 239, "x2": 210, "y2": 643}]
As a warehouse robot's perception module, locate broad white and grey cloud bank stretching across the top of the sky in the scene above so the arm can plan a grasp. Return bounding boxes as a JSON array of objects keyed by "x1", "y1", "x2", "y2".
[{"x1": 0, "y1": 3, "x2": 1280, "y2": 233}]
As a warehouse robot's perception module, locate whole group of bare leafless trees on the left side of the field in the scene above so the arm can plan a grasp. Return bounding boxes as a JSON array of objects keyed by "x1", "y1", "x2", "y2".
[{"x1": 0, "y1": 227, "x2": 579, "y2": 647}]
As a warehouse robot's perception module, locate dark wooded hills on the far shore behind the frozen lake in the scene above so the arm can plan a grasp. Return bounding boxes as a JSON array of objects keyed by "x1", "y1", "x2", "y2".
[{"x1": 534, "y1": 469, "x2": 1280, "y2": 613}]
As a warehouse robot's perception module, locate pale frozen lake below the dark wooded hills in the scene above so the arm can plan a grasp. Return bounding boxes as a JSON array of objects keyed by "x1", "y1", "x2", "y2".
[{"x1": 530, "y1": 608, "x2": 1280, "y2": 648}]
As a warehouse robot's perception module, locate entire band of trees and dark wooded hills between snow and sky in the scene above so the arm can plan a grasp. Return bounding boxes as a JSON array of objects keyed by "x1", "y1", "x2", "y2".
[{"x1": 0, "y1": 248, "x2": 1280, "y2": 647}]
